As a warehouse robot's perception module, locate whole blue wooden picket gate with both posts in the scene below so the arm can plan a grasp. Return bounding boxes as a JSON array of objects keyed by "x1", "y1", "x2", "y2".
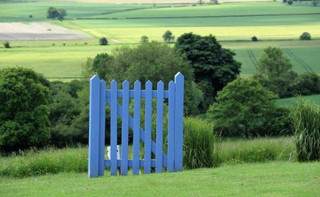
[{"x1": 88, "y1": 73, "x2": 184, "y2": 177}]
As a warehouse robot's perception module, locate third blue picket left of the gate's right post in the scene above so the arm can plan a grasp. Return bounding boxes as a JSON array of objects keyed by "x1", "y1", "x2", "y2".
[{"x1": 144, "y1": 81, "x2": 152, "y2": 174}]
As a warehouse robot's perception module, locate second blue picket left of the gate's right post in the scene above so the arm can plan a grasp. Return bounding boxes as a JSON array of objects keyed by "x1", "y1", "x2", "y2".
[{"x1": 156, "y1": 81, "x2": 164, "y2": 173}]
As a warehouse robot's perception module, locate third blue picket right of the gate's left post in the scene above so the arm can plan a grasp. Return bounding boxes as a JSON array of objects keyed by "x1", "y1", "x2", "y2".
[{"x1": 121, "y1": 80, "x2": 129, "y2": 175}]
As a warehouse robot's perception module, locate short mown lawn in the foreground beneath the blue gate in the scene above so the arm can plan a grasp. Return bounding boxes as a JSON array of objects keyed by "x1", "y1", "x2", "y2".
[{"x1": 0, "y1": 162, "x2": 320, "y2": 196}]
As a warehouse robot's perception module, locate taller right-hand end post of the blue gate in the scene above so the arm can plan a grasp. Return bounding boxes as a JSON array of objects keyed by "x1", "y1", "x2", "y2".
[{"x1": 174, "y1": 72, "x2": 184, "y2": 171}]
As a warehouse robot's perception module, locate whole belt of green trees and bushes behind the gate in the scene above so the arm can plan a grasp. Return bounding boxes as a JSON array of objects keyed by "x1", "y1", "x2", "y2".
[{"x1": 0, "y1": 33, "x2": 320, "y2": 152}]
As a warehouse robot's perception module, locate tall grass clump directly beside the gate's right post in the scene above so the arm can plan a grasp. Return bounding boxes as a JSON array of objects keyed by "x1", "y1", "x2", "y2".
[{"x1": 183, "y1": 117, "x2": 214, "y2": 169}]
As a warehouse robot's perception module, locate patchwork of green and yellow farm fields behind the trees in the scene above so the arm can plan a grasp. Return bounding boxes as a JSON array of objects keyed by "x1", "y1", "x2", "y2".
[{"x1": 0, "y1": 0, "x2": 320, "y2": 79}]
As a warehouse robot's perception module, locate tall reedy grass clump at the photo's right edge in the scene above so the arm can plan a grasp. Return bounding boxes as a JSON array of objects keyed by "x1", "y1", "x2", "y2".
[{"x1": 292, "y1": 99, "x2": 320, "y2": 162}]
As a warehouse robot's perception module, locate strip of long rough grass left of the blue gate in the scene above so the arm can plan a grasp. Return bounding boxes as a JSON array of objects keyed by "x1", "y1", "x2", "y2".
[{"x1": 0, "y1": 147, "x2": 88, "y2": 177}]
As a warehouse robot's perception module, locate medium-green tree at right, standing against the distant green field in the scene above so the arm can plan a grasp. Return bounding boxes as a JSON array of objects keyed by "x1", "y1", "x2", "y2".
[{"x1": 253, "y1": 47, "x2": 297, "y2": 98}]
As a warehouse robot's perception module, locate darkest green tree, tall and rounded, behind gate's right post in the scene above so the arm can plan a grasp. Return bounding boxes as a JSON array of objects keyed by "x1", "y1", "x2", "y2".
[{"x1": 175, "y1": 33, "x2": 241, "y2": 112}]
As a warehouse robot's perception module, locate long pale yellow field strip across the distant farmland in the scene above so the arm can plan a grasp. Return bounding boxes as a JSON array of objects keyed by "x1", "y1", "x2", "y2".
[{"x1": 82, "y1": 23, "x2": 320, "y2": 43}]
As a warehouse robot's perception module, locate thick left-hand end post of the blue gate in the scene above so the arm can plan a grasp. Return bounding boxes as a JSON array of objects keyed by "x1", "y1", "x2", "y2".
[{"x1": 88, "y1": 75, "x2": 100, "y2": 177}]
